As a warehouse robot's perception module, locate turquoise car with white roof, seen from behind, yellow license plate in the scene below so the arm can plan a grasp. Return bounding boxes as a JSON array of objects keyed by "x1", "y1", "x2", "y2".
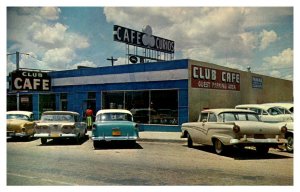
[{"x1": 91, "y1": 109, "x2": 139, "y2": 149}]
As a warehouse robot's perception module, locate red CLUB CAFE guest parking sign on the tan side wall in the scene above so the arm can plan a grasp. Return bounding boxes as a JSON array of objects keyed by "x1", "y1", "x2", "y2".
[{"x1": 191, "y1": 65, "x2": 240, "y2": 91}]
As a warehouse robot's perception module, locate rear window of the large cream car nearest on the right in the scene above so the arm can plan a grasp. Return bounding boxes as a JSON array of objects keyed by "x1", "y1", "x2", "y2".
[{"x1": 218, "y1": 112, "x2": 259, "y2": 122}]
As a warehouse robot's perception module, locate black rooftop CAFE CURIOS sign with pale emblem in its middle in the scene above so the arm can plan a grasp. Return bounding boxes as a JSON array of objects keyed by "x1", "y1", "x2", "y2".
[{"x1": 114, "y1": 25, "x2": 175, "y2": 53}]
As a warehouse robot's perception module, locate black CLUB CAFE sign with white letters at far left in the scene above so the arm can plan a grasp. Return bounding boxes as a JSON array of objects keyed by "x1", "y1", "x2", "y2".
[{"x1": 11, "y1": 71, "x2": 51, "y2": 91}]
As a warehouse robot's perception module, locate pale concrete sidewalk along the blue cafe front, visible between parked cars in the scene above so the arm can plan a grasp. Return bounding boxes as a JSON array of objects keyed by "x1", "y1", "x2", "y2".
[{"x1": 87, "y1": 131, "x2": 186, "y2": 143}]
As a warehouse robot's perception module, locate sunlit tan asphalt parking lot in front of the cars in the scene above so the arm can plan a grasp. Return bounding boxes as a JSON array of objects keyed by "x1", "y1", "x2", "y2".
[{"x1": 7, "y1": 135, "x2": 294, "y2": 186}]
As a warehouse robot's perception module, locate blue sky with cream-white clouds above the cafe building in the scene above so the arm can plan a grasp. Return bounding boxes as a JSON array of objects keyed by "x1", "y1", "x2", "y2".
[{"x1": 6, "y1": 6, "x2": 294, "y2": 80}]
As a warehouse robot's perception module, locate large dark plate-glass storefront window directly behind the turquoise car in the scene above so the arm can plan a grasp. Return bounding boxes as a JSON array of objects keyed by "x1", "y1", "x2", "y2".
[{"x1": 102, "y1": 90, "x2": 178, "y2": 125}]
